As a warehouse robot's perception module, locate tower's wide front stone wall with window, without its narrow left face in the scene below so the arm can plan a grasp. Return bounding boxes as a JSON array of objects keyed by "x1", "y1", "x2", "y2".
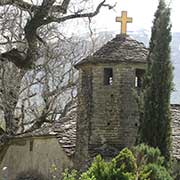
[{"x1": 89, "y1": 64, "x2": 145, "y2": 157}]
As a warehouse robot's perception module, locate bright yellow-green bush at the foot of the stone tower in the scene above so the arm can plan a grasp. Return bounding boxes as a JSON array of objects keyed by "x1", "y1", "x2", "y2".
[{"x1": 81, "y1": 148, "x2": 136, "y2": 180}]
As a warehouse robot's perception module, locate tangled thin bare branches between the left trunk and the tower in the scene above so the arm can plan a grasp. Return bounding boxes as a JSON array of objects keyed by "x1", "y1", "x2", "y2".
[{"x1": 15, "y1": 34, "x2": 83, "y2": 132}]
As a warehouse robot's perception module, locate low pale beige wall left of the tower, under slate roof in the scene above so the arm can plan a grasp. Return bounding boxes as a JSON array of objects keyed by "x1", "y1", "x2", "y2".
[{"x1": 0, "y1": 137, "x2": 73, "y2": 180}]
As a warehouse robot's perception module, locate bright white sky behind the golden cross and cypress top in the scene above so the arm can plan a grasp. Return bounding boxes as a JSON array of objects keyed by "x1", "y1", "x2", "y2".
[{"x1": 25, "y1": 0, "x2": 180, "y2": 35}]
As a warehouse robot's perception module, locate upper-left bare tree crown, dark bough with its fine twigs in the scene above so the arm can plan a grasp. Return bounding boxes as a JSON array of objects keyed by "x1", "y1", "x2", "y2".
[{"x1": 0, "y1": 0, "x2": 112, "y2": 69}]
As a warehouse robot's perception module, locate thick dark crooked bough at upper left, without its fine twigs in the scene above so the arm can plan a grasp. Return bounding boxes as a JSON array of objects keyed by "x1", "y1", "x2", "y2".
[{"x1": 0, "y1": 0, "x2": 112, "y2": 69}]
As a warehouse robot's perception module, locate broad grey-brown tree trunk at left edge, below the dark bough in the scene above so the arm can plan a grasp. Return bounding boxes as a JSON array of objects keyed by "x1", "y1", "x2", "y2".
[{"x1": 0, "y1": 62, "x2": 25, "y2": 134}]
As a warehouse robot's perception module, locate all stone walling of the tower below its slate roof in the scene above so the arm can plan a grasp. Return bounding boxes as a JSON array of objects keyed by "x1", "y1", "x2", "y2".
[{"x1": 76, "y1": 63, "x2": 145, "y2": 167}]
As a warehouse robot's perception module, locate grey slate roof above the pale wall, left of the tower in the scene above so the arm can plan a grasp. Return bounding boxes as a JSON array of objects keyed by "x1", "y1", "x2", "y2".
[{"x1": 15, "y1": 110, "x2": 77, "y2": 156}]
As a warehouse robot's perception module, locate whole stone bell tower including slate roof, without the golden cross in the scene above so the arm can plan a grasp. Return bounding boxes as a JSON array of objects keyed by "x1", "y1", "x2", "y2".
[{"x1": 75, "y1": 10, "x2": 148, "y2": 167}]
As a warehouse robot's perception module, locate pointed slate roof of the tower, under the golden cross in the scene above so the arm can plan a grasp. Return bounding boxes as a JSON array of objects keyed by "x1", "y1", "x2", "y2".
[{"x1": 75, "y1": 35, "x2": 148, "y2": 68}]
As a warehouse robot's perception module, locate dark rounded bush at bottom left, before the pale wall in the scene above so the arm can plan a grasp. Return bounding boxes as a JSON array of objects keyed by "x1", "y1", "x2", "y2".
[{"x1": 15, "y1": 170, "x2": 47, "y2": 180}]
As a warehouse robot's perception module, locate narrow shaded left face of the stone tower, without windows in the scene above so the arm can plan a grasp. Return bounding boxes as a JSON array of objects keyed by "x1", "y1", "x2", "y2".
[{"x1": 74, "y1": 66, "x2": 93, "y2": 170}]
